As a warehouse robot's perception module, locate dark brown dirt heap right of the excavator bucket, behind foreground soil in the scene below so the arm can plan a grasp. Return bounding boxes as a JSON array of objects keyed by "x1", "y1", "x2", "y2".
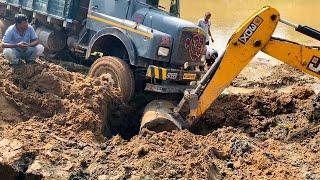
[{"x1": 194, "y1": 87, "x2": 319, "y2": 136}]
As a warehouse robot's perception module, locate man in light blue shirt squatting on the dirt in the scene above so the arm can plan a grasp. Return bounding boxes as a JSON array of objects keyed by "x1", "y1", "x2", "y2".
[{"x1": 2, "y1": 14, "x2": 44, "y2": 65}]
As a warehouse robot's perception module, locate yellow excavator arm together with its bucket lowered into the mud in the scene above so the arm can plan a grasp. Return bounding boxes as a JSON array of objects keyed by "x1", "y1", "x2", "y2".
[{"x1": 141, "y1": 6, "x2": 320, "y2": 131}]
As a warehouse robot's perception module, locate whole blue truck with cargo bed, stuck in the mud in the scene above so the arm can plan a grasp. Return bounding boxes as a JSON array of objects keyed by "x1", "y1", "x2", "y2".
[{"x1": 0, "y1": 0, "x2": 205, "y2": 101}]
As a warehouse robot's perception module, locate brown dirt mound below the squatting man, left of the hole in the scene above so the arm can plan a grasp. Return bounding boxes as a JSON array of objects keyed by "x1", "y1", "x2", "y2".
[{"x1": 0, "y1": 58, "x2": 120, "y2": 141}]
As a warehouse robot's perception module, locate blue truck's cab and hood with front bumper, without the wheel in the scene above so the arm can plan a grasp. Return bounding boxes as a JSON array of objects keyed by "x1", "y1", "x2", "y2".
[{"x1": 86, "y1": 0, "x2": 205, "y2": 100}]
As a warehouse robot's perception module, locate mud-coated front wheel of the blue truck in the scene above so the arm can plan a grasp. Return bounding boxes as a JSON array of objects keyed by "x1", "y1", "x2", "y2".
[{"x1": 88, "y1": 56, "x2": 135, "y2": 102}]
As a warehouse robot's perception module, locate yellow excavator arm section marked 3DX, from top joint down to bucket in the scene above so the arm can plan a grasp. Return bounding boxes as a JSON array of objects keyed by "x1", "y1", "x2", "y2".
[{"x1": 187, "y1": 7, "x2": 280, "y2": 124}]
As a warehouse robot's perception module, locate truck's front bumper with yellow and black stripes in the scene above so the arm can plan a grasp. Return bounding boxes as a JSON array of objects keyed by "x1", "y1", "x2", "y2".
[{"x1": 146, "y1": 65, "x2": 201, "y2": 81}]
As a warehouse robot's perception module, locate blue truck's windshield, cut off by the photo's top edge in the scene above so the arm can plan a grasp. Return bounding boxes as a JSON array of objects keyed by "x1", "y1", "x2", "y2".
[{"x1": 140, "y1": 0, "x2": 180, "y2": 17}]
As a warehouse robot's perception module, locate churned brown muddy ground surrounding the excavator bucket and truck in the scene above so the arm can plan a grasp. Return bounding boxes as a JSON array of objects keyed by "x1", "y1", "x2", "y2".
[{"x1": 0, "y1": 56, "x2": 320, "y2": 180}]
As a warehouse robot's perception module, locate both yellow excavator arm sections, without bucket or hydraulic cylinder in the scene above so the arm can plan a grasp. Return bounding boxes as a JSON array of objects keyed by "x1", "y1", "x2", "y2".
[{"x1": 187, "y1": 7, "x2": 320, "y2": 124}]
